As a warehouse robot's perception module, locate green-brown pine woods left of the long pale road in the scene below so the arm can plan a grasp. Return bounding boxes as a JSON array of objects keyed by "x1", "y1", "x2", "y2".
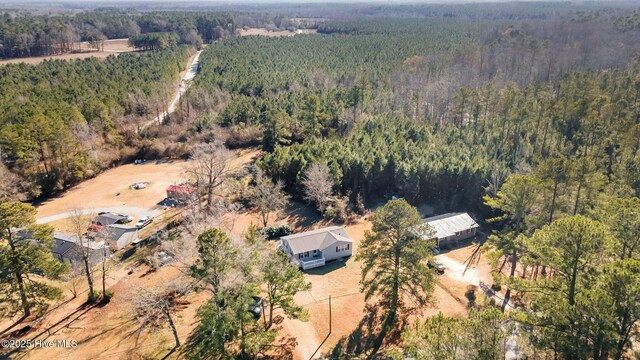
[{"x1": 0, "y1": 48, "x2": 192, "y2": 196}]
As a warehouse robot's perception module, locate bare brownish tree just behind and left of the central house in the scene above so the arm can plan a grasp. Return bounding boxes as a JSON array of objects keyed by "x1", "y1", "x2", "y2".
[{"x1": 249, "y1": 167, "x2": 289, "y2": 226}]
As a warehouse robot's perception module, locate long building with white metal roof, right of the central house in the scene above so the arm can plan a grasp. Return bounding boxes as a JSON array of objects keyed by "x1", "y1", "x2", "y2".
[{"x1": 424, "y1": 213, "x2": 480, "y2": 248}]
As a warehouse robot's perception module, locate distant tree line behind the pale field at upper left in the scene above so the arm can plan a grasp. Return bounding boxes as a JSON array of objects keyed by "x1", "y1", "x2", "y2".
[{"x1": 0, "y1": 10, "x2": 235, "y2": 58}]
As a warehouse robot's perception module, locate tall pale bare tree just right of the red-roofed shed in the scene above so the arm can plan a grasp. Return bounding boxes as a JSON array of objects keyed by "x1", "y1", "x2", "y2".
[{"x1": 187, "y1": 140, "x2": 231, "y2": 210}]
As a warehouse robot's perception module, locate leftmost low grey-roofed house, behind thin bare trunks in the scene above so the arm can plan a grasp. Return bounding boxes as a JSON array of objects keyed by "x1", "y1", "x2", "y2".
[{"x1": 52, "y1": 231, "x2": 109, "y2": 267}]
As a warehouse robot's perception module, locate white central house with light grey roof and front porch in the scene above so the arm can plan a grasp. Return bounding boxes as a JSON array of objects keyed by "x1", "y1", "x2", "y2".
[{"x1": 279, "y1": 226, "x2": 353, "y2": 270}]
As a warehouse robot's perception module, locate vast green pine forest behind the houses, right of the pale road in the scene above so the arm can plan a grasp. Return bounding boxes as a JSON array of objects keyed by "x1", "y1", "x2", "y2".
[{"x1": 188, "y1": 12, "x2": 638, "y2": 212}]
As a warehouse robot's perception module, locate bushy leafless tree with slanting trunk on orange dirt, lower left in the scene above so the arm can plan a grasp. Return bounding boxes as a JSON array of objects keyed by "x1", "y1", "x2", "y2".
[{"x1": 130, "y1": 284, "x2": 188, "y2": 347}]
